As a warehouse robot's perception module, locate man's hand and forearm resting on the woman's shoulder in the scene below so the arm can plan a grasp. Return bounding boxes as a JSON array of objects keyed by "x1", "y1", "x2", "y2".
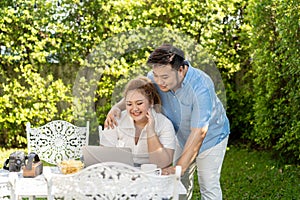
[{"x1": 104, "y1": 98, "x2": 126, "y2": 128}]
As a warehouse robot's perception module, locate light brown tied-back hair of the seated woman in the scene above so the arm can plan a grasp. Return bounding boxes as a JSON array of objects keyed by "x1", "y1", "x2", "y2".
[{"x1": 124, "y1": 76, "x2": 161, "y2": 112}]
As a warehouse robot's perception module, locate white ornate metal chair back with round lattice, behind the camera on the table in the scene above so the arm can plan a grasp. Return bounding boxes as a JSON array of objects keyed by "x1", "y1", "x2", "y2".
[{"x1": 26, "y1": 120, "x2": 89, "y2": 165}]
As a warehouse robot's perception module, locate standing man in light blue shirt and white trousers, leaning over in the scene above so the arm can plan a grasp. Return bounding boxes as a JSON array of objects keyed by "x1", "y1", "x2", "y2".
[{"x1": 105, "y1": 44, "x2": 230, "y2": 200}]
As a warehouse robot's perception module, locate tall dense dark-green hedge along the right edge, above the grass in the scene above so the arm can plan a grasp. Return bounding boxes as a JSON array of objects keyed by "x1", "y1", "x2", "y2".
[{"x1": 249, "y1": 1, "x2": 300, "y2": 161}]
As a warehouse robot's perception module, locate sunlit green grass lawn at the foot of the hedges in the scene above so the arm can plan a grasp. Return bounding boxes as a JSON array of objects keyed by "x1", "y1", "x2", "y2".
[{"x1": 0, "y1": 146, "x2": 300, "y2": 200}]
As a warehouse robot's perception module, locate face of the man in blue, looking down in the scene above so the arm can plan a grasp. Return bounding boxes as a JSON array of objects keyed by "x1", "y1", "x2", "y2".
[{"x1": 152, "y1": 64, "x2": 183, "y2": 92}]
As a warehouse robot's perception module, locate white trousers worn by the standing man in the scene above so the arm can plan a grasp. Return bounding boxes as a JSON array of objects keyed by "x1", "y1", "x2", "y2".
[{"x1": 180, "y1": 137, "x2": 228, "y2": 200}]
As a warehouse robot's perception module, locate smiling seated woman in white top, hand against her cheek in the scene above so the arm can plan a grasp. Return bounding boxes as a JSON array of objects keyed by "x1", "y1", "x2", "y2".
[{"x1": 100, "y1": 76, "x2": 176, "y2": 168}]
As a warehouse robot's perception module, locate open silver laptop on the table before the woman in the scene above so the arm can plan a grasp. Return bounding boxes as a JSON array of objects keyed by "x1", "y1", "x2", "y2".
[{"x1": 82, "y1": 145, "x2": 134, "y2": 167}]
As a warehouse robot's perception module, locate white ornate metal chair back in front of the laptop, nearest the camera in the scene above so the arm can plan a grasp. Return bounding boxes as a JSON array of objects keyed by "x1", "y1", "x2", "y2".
[{"x1": 47, "y1": 162, "x2": 181, "y2": 200}]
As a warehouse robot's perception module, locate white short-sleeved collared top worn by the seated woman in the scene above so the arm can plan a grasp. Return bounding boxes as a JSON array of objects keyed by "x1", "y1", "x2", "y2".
[{"x1": 100, "y1": 109, "x2": 176, "y2": 164}]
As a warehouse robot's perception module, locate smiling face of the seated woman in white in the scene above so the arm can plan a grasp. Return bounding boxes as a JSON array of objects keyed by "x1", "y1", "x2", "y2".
[{"x1": 125, "y1": 90, "x2": 150, "y2": 123}]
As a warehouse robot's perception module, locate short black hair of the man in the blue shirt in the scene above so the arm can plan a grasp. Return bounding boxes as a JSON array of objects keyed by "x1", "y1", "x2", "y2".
[{"x1": 147, "y1": 44, "x2": 185, "y2": 70}]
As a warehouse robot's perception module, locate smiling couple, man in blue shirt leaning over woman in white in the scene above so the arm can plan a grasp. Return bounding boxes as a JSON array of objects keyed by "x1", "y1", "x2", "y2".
[{"x1": 104, "y1": 44, "x2": 230, "y2": 200}]
